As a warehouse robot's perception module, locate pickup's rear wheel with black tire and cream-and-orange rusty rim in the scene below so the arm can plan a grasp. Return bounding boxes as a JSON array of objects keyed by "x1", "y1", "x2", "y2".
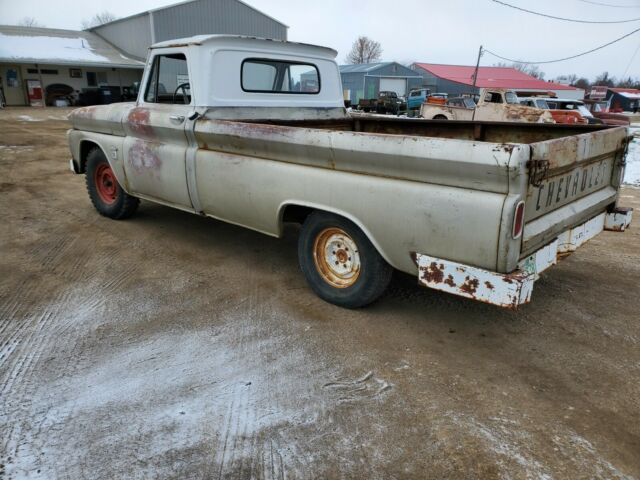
[{"x1": 298, "y1": 211, "x2": 393, "y2": 308}]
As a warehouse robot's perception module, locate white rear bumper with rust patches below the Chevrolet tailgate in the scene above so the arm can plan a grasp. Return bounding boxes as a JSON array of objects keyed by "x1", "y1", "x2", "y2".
[{"x1": 417, "y1": 208, "x2": 633, "y2": 309}]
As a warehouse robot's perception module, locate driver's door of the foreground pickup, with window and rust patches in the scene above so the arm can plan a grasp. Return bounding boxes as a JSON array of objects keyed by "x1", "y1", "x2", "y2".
[{"x1": 123, "y1": 49, "x2": 194, "y2": 210}]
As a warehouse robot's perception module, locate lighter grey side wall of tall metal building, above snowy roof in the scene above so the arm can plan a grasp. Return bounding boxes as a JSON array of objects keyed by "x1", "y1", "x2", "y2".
[{"x1": 93, "y1": 13, "x2": 152, "y2": 60}]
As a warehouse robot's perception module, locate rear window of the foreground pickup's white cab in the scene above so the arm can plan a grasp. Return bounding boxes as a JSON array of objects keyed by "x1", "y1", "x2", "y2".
[{"x1": 240, "y1": 58, "x2": 320, "y2": 94}]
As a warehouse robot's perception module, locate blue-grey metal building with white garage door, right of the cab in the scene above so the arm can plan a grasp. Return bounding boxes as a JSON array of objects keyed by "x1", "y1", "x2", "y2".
[{"x1": 340, "y1": 62, "x2": 422, "y2": 105}]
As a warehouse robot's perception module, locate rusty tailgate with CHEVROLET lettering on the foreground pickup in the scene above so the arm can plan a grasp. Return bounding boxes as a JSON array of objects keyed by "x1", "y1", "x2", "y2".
[{"x1": 521, "y1": 127, "x2": 628, "y2": 256}]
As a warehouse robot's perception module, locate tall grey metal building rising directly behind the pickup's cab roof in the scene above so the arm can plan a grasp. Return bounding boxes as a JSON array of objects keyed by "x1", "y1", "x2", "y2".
[{"x1": 91, "y1": 0, "x2": 289, "y2": 60}]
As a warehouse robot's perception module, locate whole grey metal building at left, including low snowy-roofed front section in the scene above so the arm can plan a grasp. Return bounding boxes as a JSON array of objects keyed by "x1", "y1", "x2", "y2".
[{"x1": 0, "y1": 0, "x2": 289, "y2": 105}]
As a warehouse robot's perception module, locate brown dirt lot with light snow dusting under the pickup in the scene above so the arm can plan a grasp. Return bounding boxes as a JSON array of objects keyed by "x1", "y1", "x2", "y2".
[{"x1": 0, "y1": 109, "x2": 640, "y2": 479}]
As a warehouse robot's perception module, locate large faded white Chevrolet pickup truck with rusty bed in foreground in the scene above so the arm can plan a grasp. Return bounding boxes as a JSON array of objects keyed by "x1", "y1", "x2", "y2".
[{"x1": 68, "y1": 36, "x2": 631, "y2": 308}]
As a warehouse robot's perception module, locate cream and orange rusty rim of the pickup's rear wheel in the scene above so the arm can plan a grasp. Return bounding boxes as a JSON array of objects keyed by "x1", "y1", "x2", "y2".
[{"x1": 313, "y1": 227, "x2": 361, "y2": 288}]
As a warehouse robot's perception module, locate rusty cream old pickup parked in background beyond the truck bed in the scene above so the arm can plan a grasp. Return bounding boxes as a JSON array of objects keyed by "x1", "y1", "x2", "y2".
[{"x1": 420, "y1": 88, "x2": 554, "y2": 123}]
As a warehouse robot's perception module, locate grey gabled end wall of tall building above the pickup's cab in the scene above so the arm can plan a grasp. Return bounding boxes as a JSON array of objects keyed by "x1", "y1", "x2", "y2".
[{"x1": 152, "y1": 0, "x2": 287, "y2": 42}]
